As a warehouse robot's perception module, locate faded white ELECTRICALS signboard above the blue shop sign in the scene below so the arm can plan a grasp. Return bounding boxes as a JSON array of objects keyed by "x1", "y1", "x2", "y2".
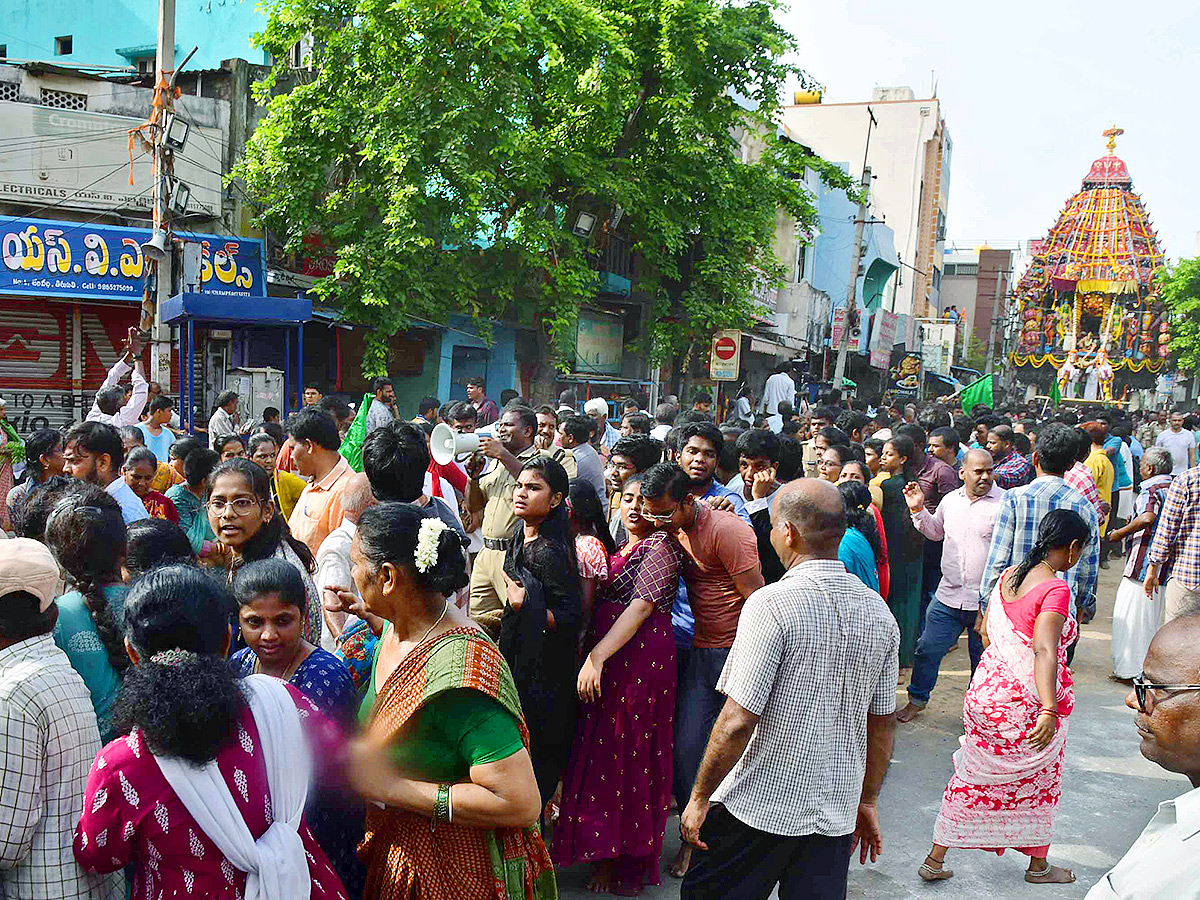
[{"x1": 0, "y1": 101, "x2": 224, "y2": 218}]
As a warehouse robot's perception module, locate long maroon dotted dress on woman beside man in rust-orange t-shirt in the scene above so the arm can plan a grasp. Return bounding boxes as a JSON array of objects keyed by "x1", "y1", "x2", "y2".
[{"x1": 551, "y1": 532, "x2": 683, "y2": 895}]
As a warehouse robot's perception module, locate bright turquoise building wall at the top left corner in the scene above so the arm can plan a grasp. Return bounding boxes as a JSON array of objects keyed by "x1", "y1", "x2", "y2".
[{"x1": 0, "y1": 0, "x2": 266, "y2": 70}]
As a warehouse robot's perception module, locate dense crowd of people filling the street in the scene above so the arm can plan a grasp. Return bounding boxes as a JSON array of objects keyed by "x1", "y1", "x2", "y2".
[{"x1": 7, "y1": 335, "x2": 1200, "y2": 900}]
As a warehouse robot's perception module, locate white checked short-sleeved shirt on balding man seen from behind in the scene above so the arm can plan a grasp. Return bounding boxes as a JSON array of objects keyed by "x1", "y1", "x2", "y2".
[{"x1": 712, "y1": 559, "x2": 900, "y2": 838}]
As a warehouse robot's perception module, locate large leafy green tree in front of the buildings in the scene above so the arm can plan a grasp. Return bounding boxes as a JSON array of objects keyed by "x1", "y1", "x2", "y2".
[{"x1": 236, "y1": 0, "x2": 850, "y2": 379}]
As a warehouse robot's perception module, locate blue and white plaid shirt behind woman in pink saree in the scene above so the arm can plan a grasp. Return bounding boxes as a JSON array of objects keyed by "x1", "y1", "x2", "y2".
[{"x1": 979, "y1": 475, "x2": 1100, "y2": 616}]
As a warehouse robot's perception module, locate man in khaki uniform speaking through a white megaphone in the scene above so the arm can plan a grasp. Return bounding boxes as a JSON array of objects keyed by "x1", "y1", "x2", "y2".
[{"x1": 460, "y1": 407, "x2": 575, "y2": 618}]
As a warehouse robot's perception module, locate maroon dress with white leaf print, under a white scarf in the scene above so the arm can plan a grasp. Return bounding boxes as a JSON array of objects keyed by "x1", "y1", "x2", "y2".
[{"x1": 74, "y1": 685, "x2": 347, "y2": 900}]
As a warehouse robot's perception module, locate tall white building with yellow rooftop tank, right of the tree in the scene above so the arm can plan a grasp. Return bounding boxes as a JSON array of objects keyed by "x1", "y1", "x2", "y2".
[{"x1": 782, "y1": 88, "x2": 950, "y2": 316}]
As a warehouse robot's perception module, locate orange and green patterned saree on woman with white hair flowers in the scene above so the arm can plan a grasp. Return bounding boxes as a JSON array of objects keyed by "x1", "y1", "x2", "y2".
[{"x1": 359, "y1": 628, "x2": 558, "y2": 900}]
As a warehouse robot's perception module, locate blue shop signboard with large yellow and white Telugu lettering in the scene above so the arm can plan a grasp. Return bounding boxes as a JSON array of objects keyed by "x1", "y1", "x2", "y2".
[{"x1": 0, "y1": 218, "x2": 266, "y2": 302}]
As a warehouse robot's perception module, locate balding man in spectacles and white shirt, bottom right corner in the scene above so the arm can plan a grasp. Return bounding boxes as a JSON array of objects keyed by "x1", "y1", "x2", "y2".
[{"x1": 1087, "y1": 616, "x2": 1200, "y2": 900}]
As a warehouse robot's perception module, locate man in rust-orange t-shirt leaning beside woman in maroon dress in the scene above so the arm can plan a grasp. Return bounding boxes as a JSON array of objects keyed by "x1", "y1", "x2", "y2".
[{"x1": 642, "y1": 463, "x2": 763, "y2": 874}]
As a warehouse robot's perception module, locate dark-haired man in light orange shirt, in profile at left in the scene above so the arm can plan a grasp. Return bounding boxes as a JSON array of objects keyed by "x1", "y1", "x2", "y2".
[{"x1": 287, "y1": 407, "x2": 354, "y2": 557}]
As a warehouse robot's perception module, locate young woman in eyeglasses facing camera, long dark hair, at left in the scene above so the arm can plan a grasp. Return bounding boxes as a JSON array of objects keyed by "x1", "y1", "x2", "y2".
[{"x1": 208, "y1": 460, "x2": 320, "y2": 646}]
